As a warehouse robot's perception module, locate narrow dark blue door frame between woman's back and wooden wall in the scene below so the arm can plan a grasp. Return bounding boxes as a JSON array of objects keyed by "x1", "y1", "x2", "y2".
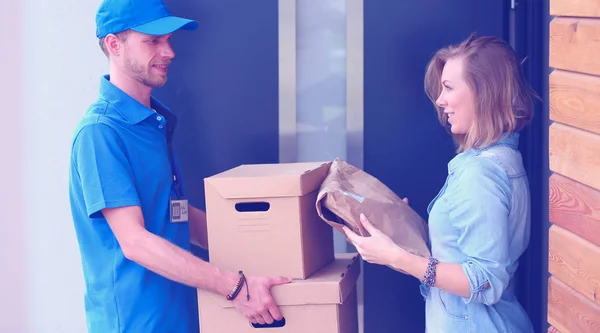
[{"x1": 511, "y1": 0, "x2": 551, "y2": 332}]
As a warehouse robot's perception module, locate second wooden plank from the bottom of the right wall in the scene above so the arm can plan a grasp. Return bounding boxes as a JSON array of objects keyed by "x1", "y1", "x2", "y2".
[{"x1": 548, "y1": 225, "x2": 600, "y2": 306}]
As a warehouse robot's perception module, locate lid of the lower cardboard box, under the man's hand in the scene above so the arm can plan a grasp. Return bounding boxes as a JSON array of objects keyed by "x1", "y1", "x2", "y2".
[{"x1": 203, "y1": 253, "x2": 360, "y2": 308}]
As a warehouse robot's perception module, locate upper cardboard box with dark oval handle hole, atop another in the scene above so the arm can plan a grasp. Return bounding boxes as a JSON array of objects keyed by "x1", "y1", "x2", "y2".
[{"x1": 204, "y1": 162, "x2": 334, "y2": 279}]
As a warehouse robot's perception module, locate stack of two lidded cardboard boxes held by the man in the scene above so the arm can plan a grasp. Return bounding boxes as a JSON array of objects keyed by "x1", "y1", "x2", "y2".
[{"x1": 198, "y1": 163, "x2": 360, "y2": 333}]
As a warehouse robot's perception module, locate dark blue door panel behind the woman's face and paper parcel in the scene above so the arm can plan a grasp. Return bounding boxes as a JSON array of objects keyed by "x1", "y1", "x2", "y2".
[{"x1": 364, "y1": 0, "x2": 509, "y2": 333}]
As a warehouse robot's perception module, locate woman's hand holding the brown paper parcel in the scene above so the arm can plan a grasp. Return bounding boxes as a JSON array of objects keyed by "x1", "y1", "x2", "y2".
[{"x1": 343, "y1": 214, "x2": 408, "y2": 269}]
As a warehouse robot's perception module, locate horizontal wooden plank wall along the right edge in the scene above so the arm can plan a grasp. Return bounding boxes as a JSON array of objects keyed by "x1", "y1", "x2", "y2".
[{"x1": 548, "y1": 0, "x2": 600, "y2": 333}]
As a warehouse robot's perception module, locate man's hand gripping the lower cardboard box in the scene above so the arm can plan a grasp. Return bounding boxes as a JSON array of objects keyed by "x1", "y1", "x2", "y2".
[{"x1": 233, "y1": 276, "x2": 291, "y2": 324}]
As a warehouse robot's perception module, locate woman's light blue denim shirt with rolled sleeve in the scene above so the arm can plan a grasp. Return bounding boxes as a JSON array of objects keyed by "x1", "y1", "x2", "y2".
[{"x1": 421, "y1": 133, "x2": 533, "y2": 333}]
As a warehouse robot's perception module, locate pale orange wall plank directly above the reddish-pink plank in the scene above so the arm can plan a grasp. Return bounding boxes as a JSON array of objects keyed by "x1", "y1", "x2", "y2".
[{"x1": 549, "y1": 122, "x2": 600, "y2": 190}]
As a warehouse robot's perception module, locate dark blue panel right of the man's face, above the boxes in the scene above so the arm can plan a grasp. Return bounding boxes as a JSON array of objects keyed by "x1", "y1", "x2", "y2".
[{"x1": 155, "y1": 0, "x2": 279, "y2": 236}]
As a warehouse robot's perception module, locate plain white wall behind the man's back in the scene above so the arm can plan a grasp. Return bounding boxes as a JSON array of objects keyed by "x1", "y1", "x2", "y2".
[{"x1": 0, "y1": 0, "x2": 107, "y2": 333}]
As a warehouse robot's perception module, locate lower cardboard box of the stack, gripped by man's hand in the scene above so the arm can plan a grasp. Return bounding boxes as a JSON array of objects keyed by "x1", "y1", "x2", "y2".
[{"x1": 198, "y1": 253, "x2": 360, "y2": 333}]
